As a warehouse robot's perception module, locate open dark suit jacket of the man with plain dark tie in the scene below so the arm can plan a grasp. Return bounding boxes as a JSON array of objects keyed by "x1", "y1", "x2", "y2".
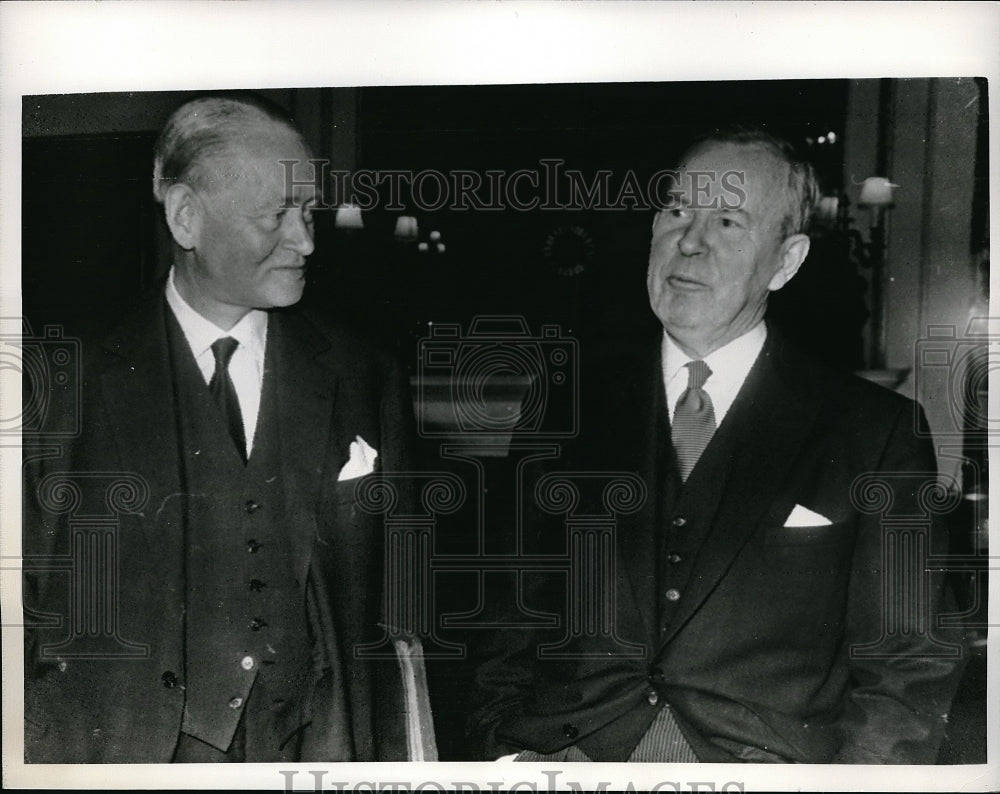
[{"x1": 24, "y1": 290, "x2": 412, "y2": 763}]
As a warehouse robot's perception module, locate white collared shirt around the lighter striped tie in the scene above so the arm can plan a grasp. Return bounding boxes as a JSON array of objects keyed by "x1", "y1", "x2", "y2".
[{"x1": 660, "y1": 322, "x2": 767, "y2": 427}]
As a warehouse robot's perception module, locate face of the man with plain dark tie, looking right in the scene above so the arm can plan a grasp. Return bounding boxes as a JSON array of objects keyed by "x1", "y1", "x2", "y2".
[{"x1": 178, "y1": 123, "x2": 317, "y2": 325}]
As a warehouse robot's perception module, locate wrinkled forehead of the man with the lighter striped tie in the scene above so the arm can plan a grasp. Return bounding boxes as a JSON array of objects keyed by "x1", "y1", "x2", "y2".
[{"x1": 678, "y1": 142, "x2": 790, "y2": 214}]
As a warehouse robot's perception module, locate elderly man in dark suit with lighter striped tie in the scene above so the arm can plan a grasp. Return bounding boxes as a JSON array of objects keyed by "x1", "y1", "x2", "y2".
[{"x1": 471, "y1": 130, "x2": 961, "y2": 763}]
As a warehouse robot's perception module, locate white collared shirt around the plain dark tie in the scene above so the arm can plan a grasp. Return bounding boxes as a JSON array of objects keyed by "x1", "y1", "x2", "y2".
[{"x1": 167, "y1": 268, "x2": 267, "y2": 457}]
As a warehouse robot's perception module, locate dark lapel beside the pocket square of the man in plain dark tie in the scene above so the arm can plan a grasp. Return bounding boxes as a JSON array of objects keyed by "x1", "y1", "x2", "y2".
[{"x1": 266, "y1": 312, "x2": 348, "y2": 576}]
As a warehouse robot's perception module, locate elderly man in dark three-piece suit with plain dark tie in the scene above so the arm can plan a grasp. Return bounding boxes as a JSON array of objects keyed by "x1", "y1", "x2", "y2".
[{"x1": 24, "y1": 97, "x2": 422, "y2": 762}]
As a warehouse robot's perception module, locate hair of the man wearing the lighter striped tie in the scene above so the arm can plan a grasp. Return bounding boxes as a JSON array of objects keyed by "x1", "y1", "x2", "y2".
[{"x1": 681, "y1": 126, "x2": 820, "y2": 238}]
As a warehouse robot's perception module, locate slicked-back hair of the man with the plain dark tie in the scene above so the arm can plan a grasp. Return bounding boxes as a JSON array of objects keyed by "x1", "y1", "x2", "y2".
[{"x1": 153, "y1": 96, "x2": 301, "y2": 204}]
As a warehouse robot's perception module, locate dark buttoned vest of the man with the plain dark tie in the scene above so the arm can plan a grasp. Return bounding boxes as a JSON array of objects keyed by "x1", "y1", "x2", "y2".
[{"x1": 168, "y1": 316, "x2": 318, "y2": 758}]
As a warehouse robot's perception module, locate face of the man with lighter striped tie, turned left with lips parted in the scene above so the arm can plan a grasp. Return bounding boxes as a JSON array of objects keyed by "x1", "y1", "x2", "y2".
[{"x1": 646, "y1": 143, "x2": 808, "y2": 357}]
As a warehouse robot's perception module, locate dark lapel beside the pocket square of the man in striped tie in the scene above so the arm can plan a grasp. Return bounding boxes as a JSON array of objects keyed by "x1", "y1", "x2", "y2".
[{"x1": 663, "y1": 328, "x2": 822, "y2": 643}]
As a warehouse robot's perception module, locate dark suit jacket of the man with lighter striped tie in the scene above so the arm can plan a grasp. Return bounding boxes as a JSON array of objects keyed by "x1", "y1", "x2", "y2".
[{"x1": 470, "y1": 328, "x2": 961, "y2": 763}]
